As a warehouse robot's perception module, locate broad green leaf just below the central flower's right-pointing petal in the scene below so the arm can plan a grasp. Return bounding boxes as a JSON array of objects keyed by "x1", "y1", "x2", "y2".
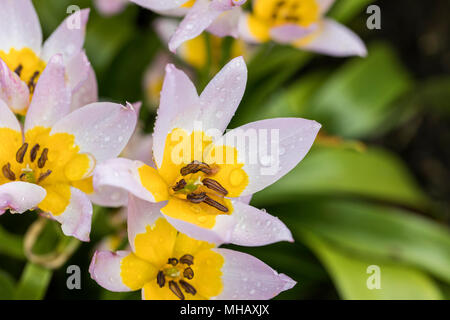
[{"x1": 254, "y1": 146, "x2": 428, "y2": 208}]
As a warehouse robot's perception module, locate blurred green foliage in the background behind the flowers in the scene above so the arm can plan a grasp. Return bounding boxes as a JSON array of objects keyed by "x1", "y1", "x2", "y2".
[{"x1": 0, "y1": 0, "x2": 450, "y2": 299}]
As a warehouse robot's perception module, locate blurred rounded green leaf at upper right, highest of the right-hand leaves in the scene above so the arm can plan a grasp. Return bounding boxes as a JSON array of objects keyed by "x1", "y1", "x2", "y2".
[{"x1": 308, "y1": 44, "x2": 412, "y2": 138}]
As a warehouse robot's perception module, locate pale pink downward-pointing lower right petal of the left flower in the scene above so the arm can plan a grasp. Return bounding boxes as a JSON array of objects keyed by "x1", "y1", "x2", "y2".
[{"x1": 51, "y1": 187, "x2": 92, "y2": 241}]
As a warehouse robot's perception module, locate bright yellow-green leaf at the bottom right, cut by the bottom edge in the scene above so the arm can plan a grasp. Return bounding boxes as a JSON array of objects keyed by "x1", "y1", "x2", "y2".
[{"x1": 305, "y1": 234, "x2": 442, "y2": 300}]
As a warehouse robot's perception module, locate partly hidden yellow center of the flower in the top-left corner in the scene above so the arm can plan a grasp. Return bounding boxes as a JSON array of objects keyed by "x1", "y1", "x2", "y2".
[{"x1": 0, "y1": 48, "x2": 46, "y2": 100}]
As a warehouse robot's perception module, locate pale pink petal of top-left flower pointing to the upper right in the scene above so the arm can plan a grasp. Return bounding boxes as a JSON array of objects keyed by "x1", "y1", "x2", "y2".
[{"x1": 42, "y1": 9, "x2": 90, "y2": 61}]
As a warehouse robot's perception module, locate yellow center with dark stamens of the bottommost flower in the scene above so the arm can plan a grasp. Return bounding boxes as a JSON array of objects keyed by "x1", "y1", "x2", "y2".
[{"x1": 121, "y1": 218, "x2": 224, "y2": 300}]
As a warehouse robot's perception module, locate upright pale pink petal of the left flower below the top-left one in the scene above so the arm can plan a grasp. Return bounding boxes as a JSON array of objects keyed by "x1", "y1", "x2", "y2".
[{"x1": 25, "y1": 54, "x2": 71, "y2": 132}]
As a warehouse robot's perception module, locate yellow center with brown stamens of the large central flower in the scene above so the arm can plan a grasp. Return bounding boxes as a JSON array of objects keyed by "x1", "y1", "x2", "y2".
[{"x1": 139, "y1": 129, "x2": 248, "y2": 228}]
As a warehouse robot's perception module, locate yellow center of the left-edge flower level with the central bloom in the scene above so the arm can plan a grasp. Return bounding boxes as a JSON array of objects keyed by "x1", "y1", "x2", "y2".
[{"x1": 0, "y1": 127, "x2": 95, "y2": 215}]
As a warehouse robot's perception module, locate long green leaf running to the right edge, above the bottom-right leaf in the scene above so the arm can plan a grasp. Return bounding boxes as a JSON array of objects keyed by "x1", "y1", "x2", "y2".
[{"x1": 277, "y1": 198, "x2": 450, "y2": 283}]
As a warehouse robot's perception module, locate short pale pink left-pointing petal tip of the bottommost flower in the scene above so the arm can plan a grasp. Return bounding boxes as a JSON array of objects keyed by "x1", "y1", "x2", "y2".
[{"x1": 89, "y1": 251, "x2": 131, "y2": 292}]
